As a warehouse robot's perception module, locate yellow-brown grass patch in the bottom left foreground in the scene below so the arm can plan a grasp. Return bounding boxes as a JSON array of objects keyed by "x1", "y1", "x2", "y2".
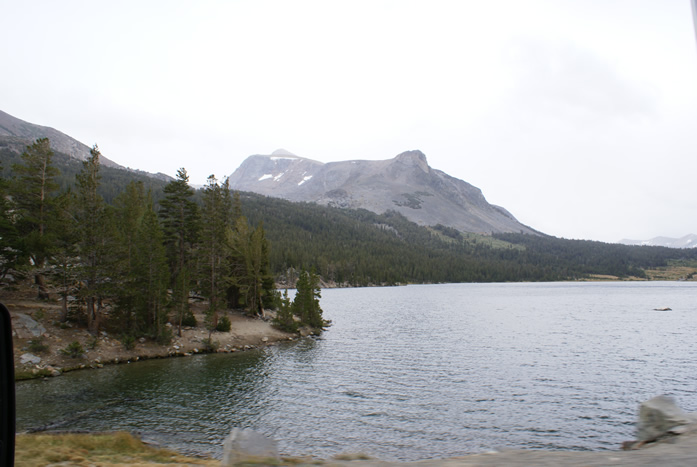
[{"x1": 15, "y1": 433, "x2": 220, "y2": 467}]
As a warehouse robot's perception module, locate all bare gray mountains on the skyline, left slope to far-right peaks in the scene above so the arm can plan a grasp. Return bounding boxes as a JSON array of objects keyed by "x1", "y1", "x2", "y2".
[{"x1": 0, "y1": 110, "x2": 697, "y2": 248}]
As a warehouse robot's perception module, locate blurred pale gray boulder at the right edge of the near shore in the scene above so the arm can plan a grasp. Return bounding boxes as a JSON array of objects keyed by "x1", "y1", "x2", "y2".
[{"x1": 637, "y1": 396, "x2": 697, "y2": 442}]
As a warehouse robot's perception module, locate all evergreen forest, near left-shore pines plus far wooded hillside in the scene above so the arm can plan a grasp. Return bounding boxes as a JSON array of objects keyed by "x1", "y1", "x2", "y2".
[{"x1": 0, "y1": 139, "x2": 697, "y2": 339}]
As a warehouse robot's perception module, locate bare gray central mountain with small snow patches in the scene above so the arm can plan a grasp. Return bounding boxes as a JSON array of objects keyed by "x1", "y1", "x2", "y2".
[{"x1": 229, "y1": 150, "x2": 538, "y2": 234}]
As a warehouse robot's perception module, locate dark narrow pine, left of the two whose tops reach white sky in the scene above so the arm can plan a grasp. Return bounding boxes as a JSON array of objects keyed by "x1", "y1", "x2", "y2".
[{"x1": 160, "y1": 168, "x2": 199, "y2": 336}]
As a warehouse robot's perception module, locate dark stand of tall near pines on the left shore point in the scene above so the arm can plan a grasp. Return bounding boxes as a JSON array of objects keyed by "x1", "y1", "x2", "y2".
[{"x1": 0, "y1": 138, "x2": 327, "y2": 343}]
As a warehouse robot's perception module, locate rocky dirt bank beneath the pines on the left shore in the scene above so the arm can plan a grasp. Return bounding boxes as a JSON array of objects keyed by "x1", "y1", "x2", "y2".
[{"x1": 8, "y1": 299, "x2": 298, "y2": 380}]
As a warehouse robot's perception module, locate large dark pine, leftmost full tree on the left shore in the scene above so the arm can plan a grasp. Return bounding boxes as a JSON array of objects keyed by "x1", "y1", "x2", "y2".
[{"x1": 12, "y1": 138, "x2": 59, "y2": 299}]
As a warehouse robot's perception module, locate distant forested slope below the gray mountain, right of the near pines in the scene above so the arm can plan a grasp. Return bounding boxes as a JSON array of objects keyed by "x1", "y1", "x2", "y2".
[{"x1": 242, "y1": 193, "x2": 697, "y2": 285}]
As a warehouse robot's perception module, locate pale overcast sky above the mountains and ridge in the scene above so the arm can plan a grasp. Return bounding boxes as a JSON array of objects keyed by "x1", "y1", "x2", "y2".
[{"x1": 0, "y1": 0, "x2": 697, "y2": 242}]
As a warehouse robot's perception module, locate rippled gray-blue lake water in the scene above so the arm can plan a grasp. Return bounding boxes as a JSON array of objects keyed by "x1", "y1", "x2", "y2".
[{"x1": 17, "y1": 282, "x2": 697, "y2": 460}]
